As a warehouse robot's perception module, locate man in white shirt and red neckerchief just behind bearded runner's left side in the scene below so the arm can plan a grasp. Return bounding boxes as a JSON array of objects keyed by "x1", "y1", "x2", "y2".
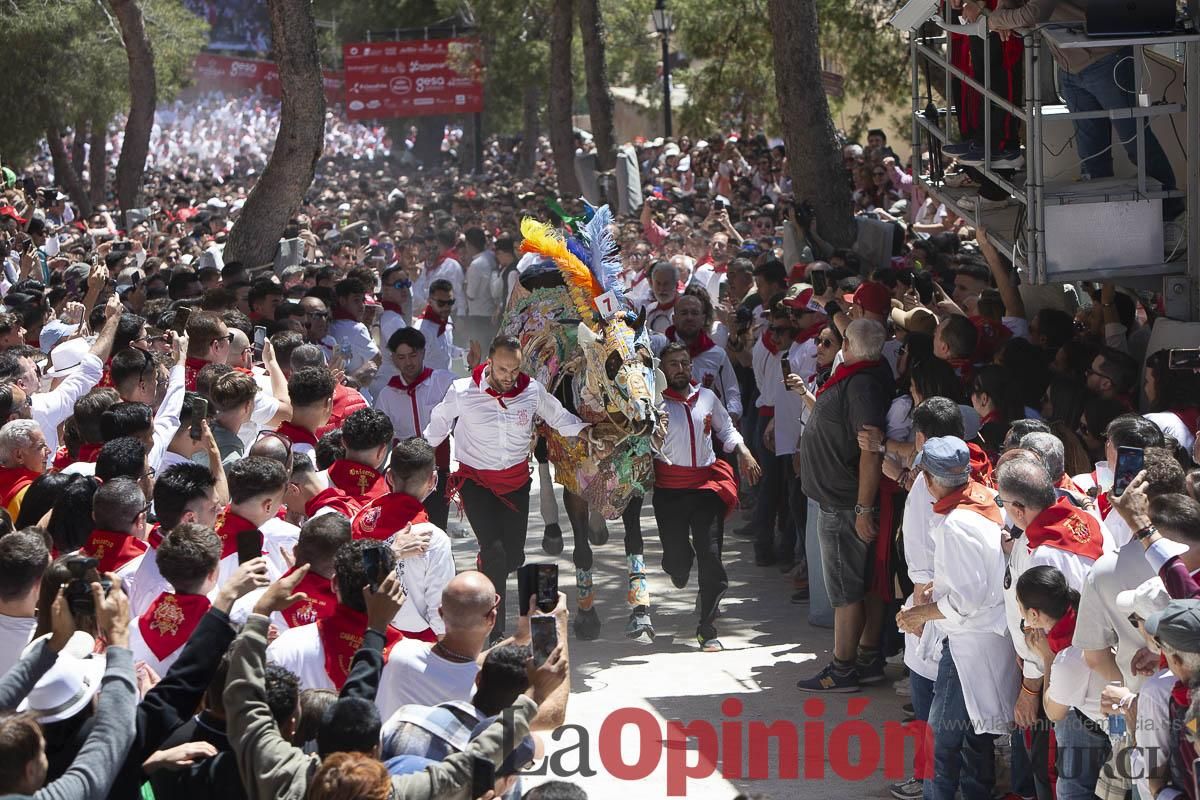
[{"x1": 376, "y1": 327, "x2": 455, "y2": 530}]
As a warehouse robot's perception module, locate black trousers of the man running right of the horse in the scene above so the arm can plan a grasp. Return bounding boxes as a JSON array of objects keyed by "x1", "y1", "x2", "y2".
[{"x1": 654, "y1": 488, "x2": 730, "y2": 639}]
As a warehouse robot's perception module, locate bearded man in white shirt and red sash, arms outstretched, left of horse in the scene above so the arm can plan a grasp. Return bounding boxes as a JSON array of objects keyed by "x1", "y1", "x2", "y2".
[{"x1": 424, "y1": 336, "x2": 588, "y2": 633}]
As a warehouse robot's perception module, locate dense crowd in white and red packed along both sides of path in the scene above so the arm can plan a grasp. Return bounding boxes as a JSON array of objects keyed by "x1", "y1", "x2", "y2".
[{"x1": 0, "y1": 77, "x2": 1200, "y2": 800}]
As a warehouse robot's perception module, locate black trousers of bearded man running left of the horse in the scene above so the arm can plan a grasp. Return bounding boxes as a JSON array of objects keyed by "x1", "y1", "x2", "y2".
[{"x1": 458, "y1": 480, "x2": 530, "y2": 631}]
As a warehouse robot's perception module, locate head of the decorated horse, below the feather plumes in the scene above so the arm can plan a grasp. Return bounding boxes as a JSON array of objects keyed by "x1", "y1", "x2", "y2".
[{"x1": 577, "y1": 311, "x2": 656, "y2": 434}]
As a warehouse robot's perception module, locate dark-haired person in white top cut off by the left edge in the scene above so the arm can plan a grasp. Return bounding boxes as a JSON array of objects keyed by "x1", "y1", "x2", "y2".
[{"x1": 0, "y1": 531, "x2": 50, "y2": 672}]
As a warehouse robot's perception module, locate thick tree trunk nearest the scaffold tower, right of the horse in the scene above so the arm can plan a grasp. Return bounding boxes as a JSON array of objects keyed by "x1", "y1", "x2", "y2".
[{"x1": 769, "y1": 0, "x2": 856, "y2": 247}]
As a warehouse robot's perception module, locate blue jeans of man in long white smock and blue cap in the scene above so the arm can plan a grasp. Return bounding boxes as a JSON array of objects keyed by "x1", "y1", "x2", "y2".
[{"x1": 913, "y1": 640, "x2": 996, "y2": 800}]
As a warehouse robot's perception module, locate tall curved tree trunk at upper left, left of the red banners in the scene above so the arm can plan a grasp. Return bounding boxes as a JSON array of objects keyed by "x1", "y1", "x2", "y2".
[{"x1": 109, "y1": 0, "x2": 158, "y2": 211}]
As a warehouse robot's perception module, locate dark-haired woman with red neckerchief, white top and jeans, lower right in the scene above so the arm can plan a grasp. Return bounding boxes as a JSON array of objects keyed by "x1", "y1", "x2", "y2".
[{"x1": 1016, "y1": 564, "x2": 1110, "y2": 800}]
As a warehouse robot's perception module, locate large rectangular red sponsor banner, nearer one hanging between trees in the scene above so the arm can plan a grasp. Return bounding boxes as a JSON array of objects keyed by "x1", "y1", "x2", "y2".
[{"x1": 342, "y1": 38, "x2": 484, "y2": 120}]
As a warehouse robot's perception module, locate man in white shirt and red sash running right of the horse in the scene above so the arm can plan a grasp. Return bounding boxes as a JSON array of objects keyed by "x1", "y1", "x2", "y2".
[{"x1": 653, "y1": 343, "x2": 761, "y2": 651}]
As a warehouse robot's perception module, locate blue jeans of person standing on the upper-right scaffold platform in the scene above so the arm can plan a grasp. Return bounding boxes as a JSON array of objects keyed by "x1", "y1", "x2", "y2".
[{"x1": 1058, "y1": 48, "x2": 1183, "y2": 218}]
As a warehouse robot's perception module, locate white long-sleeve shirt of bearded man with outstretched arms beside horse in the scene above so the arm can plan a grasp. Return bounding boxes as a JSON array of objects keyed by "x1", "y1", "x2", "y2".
[{"x1": 422, "y1": 368, "x2": 588, "y2": 470}]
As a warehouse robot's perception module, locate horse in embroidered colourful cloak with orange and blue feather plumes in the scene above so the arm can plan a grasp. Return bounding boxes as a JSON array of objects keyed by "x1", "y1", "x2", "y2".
[{"x1": 500, "y1": 206, "x2": 666, "y2": 640}]
